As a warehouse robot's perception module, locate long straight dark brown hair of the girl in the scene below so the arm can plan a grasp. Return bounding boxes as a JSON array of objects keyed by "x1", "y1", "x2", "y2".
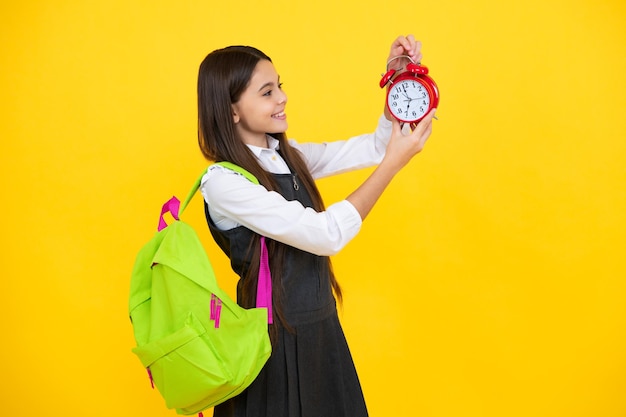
[{"x1": 198, "y1": 46, "x2": 342, "y2": 329}]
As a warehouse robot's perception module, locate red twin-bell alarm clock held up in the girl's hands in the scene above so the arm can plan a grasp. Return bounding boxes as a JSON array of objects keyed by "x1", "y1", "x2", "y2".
[{"x1": 380, "y1": 56, "x2": 439, "y2": 127}]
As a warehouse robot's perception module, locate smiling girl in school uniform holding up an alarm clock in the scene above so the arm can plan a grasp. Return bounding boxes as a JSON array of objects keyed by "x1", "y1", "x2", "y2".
[{"x1": 198, "y1": 35, "x2": 434, "y2": 417}]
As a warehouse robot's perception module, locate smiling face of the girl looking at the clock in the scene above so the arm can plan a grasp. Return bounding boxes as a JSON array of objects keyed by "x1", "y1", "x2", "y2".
[{"x1": 232, "y1": 60, "x2": 287, "y2": 147}]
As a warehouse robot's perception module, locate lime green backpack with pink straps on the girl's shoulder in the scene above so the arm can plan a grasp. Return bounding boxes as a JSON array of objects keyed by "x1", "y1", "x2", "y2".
[{"x1": 129, "y1": 163, "x2": 271, "y2": 415}]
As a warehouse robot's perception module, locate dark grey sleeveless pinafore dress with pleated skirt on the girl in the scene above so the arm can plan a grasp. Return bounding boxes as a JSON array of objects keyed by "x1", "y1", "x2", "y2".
[{"x1": 205, "y1": 170, "x2": 368, "y2": 417}]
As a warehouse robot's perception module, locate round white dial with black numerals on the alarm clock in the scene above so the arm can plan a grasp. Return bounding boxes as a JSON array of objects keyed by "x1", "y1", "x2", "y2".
[{"x1": 387, "y1": 79, "x2": 430, "y2": 122}]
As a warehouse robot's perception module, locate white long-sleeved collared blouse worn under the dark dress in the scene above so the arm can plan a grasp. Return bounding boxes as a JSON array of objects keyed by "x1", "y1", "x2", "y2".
[{"x1": 200, "y1": 116, "x2": 391, "y2": 256}]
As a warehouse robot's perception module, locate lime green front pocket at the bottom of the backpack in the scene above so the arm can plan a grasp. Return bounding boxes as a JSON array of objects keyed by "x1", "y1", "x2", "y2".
[{"x1": 133, "y1": 313, "x2": 233, "y2": 408}]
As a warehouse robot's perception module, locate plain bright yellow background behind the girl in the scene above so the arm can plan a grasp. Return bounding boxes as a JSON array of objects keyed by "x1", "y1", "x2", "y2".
[{"x1": 0, "y1": 0, "x2": 626, "y2": 417}]
